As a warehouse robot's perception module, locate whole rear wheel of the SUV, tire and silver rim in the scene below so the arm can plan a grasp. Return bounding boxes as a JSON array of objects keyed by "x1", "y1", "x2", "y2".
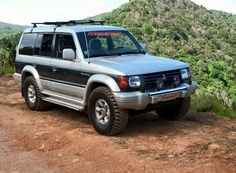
[{"x1": 23, "y1": 76, "x2": 50, "y2": 111}]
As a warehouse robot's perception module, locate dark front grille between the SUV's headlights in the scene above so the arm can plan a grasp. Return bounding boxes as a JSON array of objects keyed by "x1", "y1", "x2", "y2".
[{"x1": 143, "y1": 70, "x2": 181, "y2": 92}]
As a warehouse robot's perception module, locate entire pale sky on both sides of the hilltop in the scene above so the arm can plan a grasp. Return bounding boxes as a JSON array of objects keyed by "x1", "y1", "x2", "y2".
[{"x1": 0, "y1": 0, "x2": 236, "y2": 25}]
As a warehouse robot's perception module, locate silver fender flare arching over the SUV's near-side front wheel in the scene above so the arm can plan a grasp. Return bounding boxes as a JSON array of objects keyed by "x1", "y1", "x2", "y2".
[{"x1": 83, "y1": 74, "x2": 120, "y2": 106}]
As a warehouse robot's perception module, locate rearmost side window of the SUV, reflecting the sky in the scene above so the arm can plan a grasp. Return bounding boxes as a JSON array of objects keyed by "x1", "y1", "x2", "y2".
[{"x1": 19, "y1": 33, "x2": 37, "y2": 55}]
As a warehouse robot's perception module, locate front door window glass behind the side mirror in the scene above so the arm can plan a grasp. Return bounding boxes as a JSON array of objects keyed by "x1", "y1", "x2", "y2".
[{"x1": 55, "y1": 34, "x2": 76, "y2": 59}]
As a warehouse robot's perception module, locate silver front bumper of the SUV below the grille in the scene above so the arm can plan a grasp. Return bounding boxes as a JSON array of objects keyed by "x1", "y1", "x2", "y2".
[{"x1": 113, "y1": 81, "x2": 197, "y2": 110}]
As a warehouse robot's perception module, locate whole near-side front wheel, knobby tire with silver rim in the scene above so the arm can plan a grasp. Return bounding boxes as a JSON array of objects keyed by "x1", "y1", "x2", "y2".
[{"x1": 88, "y1": 87, "x2": 128, "y2": 135}]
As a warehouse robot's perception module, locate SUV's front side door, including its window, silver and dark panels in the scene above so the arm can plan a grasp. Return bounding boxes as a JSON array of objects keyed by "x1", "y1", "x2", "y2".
[{"x1": 51, "y1": 34, "x2": 85, "y2": 99}]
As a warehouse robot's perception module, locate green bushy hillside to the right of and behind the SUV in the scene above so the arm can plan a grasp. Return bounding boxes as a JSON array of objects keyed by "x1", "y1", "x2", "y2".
[{"x1": 91, "y1": 0, "x2": 236, "y2": 114}]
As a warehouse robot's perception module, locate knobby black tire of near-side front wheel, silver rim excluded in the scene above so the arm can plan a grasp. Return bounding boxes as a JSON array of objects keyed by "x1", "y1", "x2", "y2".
[{"x1": 88, "y1": 87, "x2": 128, "y2": 136}]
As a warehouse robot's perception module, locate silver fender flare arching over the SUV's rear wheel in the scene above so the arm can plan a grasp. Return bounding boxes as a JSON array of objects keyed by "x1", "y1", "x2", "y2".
[{"x1": 21, "y1": 65, "x2": 43, "y2": 91}]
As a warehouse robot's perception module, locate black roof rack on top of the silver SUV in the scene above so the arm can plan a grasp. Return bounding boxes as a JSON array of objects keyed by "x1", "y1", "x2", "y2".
[{"x1": 32, "y1": 20, "x2": 105, "y2": 28}]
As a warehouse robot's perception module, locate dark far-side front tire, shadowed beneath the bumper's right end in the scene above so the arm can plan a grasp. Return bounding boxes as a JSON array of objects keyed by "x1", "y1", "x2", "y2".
[{"x1": 156, "y1": 97, "x2": 191, "y2": 121}]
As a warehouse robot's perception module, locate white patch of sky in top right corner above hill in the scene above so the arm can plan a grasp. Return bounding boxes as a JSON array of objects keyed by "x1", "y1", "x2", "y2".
[{"x1": 192, "y1": 0, "x2": 236, "y2": 14}]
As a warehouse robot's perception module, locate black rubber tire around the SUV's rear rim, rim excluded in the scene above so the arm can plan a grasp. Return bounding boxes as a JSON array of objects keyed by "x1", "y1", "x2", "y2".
[{"x1": 23, "y1": 76, "x2": 51, "y2": 111}]
